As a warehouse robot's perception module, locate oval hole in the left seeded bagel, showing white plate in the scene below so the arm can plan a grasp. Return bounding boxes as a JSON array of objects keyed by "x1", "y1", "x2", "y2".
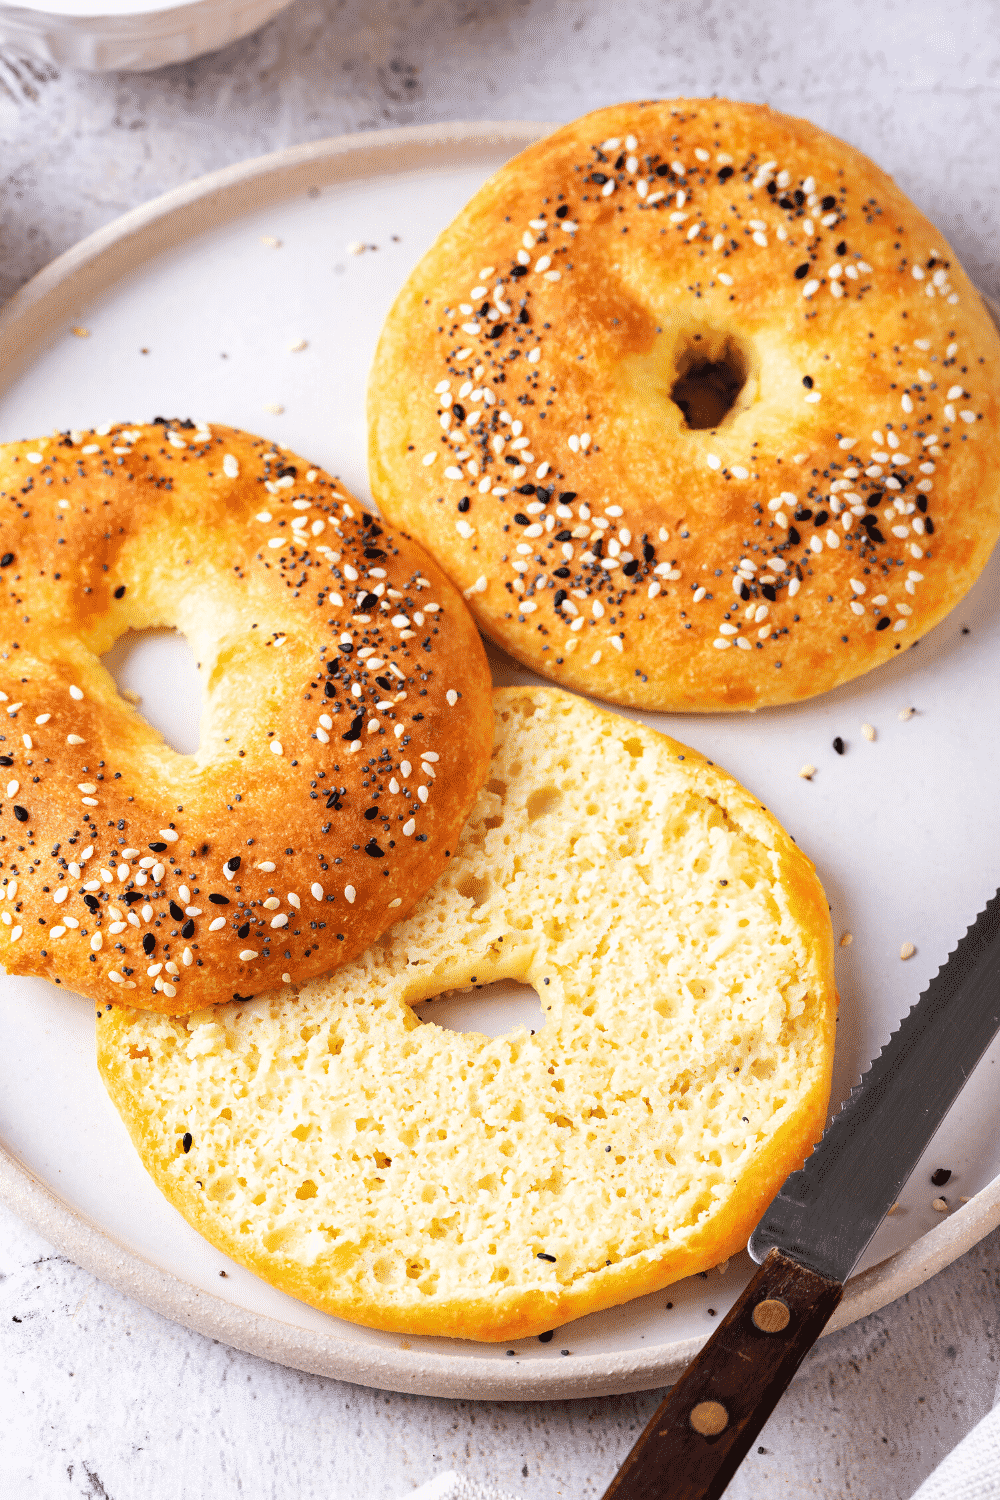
[{"x1": 102, "y1": 629, "x2": 201, "y2": 755}]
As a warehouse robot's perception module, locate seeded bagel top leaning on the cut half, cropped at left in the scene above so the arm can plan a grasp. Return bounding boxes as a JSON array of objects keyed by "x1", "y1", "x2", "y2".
[{"x1": 0, "y1": 422, "x2": 490, "y2": 1014}]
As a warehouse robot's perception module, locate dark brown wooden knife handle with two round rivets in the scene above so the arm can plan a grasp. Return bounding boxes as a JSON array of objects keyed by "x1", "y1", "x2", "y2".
[{"x1": 604, "y1": 1250, "x2": 844, "y2": 1500}]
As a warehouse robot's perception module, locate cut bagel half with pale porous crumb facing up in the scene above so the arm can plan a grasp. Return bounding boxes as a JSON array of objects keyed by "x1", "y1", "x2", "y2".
[{"x1": 99, "y1": 689, "x2": 837, "y2": 1340}]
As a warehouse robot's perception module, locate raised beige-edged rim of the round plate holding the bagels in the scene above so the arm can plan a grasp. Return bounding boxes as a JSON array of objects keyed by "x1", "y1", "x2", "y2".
[{"x1": 0, "y1": 120, "x2": 1000, "y2": 1401}]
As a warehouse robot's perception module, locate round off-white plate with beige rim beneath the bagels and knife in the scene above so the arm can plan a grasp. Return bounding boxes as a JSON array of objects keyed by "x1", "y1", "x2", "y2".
[{"x1": 0, "y1": 125, "x2": 1000, "y2": 1400}]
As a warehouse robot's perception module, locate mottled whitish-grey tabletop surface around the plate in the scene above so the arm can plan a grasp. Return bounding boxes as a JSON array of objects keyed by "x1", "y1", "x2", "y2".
[{"x1": 0, "y1": 0, "x2": 1000, "y2": 1500}]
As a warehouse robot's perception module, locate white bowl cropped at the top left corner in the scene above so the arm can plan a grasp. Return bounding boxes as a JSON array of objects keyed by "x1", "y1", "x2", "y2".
[{"x1": 0, "y1": 0, "x2": 291, "y2": 72}]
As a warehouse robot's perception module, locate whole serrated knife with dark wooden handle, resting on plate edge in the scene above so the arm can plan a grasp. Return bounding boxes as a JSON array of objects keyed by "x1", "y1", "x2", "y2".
[{"x1": 604, "y1": 891, "x2": 1000, "y2": 1500}]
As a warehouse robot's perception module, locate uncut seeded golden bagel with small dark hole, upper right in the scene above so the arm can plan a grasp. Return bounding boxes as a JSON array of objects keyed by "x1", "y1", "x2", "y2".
[{"x1": 369, "y1": 99, "x2": 1000, "y2": 711}]
